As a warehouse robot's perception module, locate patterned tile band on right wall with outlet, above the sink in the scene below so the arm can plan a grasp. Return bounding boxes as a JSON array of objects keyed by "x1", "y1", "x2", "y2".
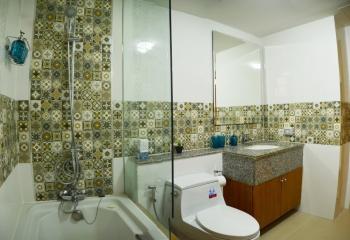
[{"x1": 265, "y1": 101, "x2": 341, "y2": 145}]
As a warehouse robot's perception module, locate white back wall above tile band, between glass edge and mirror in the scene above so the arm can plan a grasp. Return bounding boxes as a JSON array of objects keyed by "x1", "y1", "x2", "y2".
[{"x1": 172, "y1": 11, "x2": 261, "y2": 102}]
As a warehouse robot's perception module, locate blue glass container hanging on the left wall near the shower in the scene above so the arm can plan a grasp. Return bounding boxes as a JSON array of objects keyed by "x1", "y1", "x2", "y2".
[{"x1": 9, "y1": 32, "x2": 29, "y2": 65}]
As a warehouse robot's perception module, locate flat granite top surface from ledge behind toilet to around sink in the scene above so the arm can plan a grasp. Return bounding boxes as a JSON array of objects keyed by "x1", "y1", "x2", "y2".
[{"x1": 134, "y1": 141, "x2": 303, "y2": 164}]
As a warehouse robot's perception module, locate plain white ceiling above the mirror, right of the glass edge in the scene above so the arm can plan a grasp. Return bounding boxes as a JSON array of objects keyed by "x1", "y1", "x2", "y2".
[{"x1": 172, "y1": 0, "x2": 350, "y2": 37}]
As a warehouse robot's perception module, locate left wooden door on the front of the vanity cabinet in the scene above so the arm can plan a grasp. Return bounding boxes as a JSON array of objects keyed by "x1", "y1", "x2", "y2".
[{"x1": 253, "y1": 178, "x2": 281, "y2": 228}]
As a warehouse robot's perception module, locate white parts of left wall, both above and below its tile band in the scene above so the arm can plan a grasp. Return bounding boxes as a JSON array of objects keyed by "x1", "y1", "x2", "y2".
[{"x1": 0, "y1": 0, "x2": 35, "y2": 240}]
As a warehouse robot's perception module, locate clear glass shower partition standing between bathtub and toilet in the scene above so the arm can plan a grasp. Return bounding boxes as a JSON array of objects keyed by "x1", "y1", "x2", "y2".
[{"x1": 123, "y1": 0, "x2": 173, "y2": 236}]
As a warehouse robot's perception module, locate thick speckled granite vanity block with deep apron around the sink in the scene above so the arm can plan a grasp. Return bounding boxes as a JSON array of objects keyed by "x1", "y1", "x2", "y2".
[{"x1": 223, "y1": 142, "x2": 304, "y2": 186}]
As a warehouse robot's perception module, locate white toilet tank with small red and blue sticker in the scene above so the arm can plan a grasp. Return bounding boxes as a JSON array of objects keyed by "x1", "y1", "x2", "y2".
[{"x1": 167, "y1": 173, "x2": 225, "y2": 219}]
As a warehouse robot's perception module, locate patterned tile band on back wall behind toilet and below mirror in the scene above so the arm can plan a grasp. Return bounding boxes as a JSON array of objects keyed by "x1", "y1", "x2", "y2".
[{"x1": 113, "y1": 102, "x2": 263, "y2": 157}]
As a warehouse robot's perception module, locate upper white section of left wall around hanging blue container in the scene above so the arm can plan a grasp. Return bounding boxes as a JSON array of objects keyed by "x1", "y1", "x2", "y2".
[{"x1": 0, "y1": 0, "x2": 35, "y2": 100}]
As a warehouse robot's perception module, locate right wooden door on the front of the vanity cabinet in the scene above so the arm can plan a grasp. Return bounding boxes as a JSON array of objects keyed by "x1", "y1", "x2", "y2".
[{"x1": 281, "y1": 168, "x2": 303, "y2": 215}]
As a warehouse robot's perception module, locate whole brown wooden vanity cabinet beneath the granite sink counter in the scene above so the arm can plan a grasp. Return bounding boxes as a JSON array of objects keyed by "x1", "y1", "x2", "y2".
[{"x1": 224, "y1": 167, "x2": 302, "y2": 228}]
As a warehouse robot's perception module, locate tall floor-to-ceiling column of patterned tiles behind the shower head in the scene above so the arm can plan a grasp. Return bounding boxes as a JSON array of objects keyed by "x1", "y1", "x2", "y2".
[{"x1": 30, "y1": 0, "x2": 113, "y2": 200}]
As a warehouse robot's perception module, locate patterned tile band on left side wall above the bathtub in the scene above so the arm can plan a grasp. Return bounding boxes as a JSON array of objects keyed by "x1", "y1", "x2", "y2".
[{"x1": 0, "y1": 95, "x2": 18, "y2": 186}]
